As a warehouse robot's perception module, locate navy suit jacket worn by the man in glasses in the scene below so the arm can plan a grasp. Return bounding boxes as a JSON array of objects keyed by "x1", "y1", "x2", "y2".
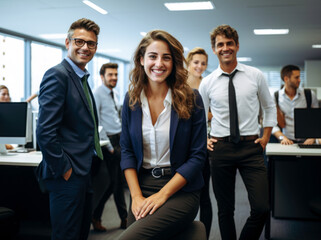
[{"x1": 37, "y1": 60, "x2": 98, "y2": 179}]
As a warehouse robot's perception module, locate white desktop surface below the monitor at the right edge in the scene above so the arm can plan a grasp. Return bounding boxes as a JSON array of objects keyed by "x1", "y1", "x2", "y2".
[{"x1": 266, "y1": 143, "x2": 321, "y2": 156}]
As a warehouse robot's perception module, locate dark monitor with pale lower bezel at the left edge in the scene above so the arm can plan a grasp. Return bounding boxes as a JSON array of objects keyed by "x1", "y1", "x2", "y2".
[{"x1": 0, "y1": 102, "x2": 28, "y2": 144}]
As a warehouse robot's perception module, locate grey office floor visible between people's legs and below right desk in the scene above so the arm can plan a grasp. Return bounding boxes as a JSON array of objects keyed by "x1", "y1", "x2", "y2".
[{"x1": 89, "y1": 174, "x2": 321, "y2": 240}]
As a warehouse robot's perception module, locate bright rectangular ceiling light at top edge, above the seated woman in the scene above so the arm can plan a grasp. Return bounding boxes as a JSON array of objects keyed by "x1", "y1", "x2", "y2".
[{"x1": 164, "y1": 1, "x2": 214, "y2": 11}]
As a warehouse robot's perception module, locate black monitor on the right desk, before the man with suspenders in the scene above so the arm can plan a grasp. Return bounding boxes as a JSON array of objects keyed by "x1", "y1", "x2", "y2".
[{"x1": 294, "y1": 108, "x2": 321, "y2": 138}]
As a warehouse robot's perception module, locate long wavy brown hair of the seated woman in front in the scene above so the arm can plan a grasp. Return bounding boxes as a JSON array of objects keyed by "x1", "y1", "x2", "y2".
[{"x1": 128, "y1": 30, "x2": 195, "y2": 119}]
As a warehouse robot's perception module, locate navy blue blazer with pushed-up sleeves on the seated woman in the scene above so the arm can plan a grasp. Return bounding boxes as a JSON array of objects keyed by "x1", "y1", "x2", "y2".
[{"x1": 120, "y1": 90, "x2": 207, "y2": 192}]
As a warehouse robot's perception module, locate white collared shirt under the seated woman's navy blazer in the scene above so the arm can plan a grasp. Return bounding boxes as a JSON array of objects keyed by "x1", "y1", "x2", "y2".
[{"x1": 140, "y1": 89, "x2": 172, "y2": 169}]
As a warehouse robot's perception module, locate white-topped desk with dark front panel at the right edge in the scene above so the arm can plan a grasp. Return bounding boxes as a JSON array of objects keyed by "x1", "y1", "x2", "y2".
[{"x1": 266, "y1": 143, "x2": 321, "y2": 237}]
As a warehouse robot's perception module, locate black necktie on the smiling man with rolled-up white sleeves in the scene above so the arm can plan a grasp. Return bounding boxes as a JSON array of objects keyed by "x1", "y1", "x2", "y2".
[{"x1": 222, "y1": 70, "x2": 240, "y2": 143}]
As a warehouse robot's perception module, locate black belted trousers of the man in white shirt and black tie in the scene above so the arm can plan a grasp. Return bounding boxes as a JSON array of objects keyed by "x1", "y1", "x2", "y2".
[{"x1": 210, "y1": 140, "x2": 269, "y2": 240}]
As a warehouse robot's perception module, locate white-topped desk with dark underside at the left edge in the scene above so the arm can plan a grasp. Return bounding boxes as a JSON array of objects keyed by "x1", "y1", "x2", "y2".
[{"x1": 0, "y1": 152, "x2": 50, "y2": 239}]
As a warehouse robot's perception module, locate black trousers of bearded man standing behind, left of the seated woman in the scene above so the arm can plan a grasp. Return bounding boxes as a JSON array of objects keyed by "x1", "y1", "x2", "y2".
[{"x1": 93, "y1": 134, "x2": 127, "y2": 220}]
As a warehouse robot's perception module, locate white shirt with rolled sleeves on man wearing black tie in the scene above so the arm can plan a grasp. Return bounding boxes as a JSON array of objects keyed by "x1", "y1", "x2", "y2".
[{"x1": 199, "y1": 63, "x2": 277, "y2": 137}]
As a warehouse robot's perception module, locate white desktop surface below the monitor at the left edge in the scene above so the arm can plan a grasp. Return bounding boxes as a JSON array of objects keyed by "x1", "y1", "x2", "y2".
[{"x1": 0, "y1": 152, "x2": 42, "y2": 167}]
